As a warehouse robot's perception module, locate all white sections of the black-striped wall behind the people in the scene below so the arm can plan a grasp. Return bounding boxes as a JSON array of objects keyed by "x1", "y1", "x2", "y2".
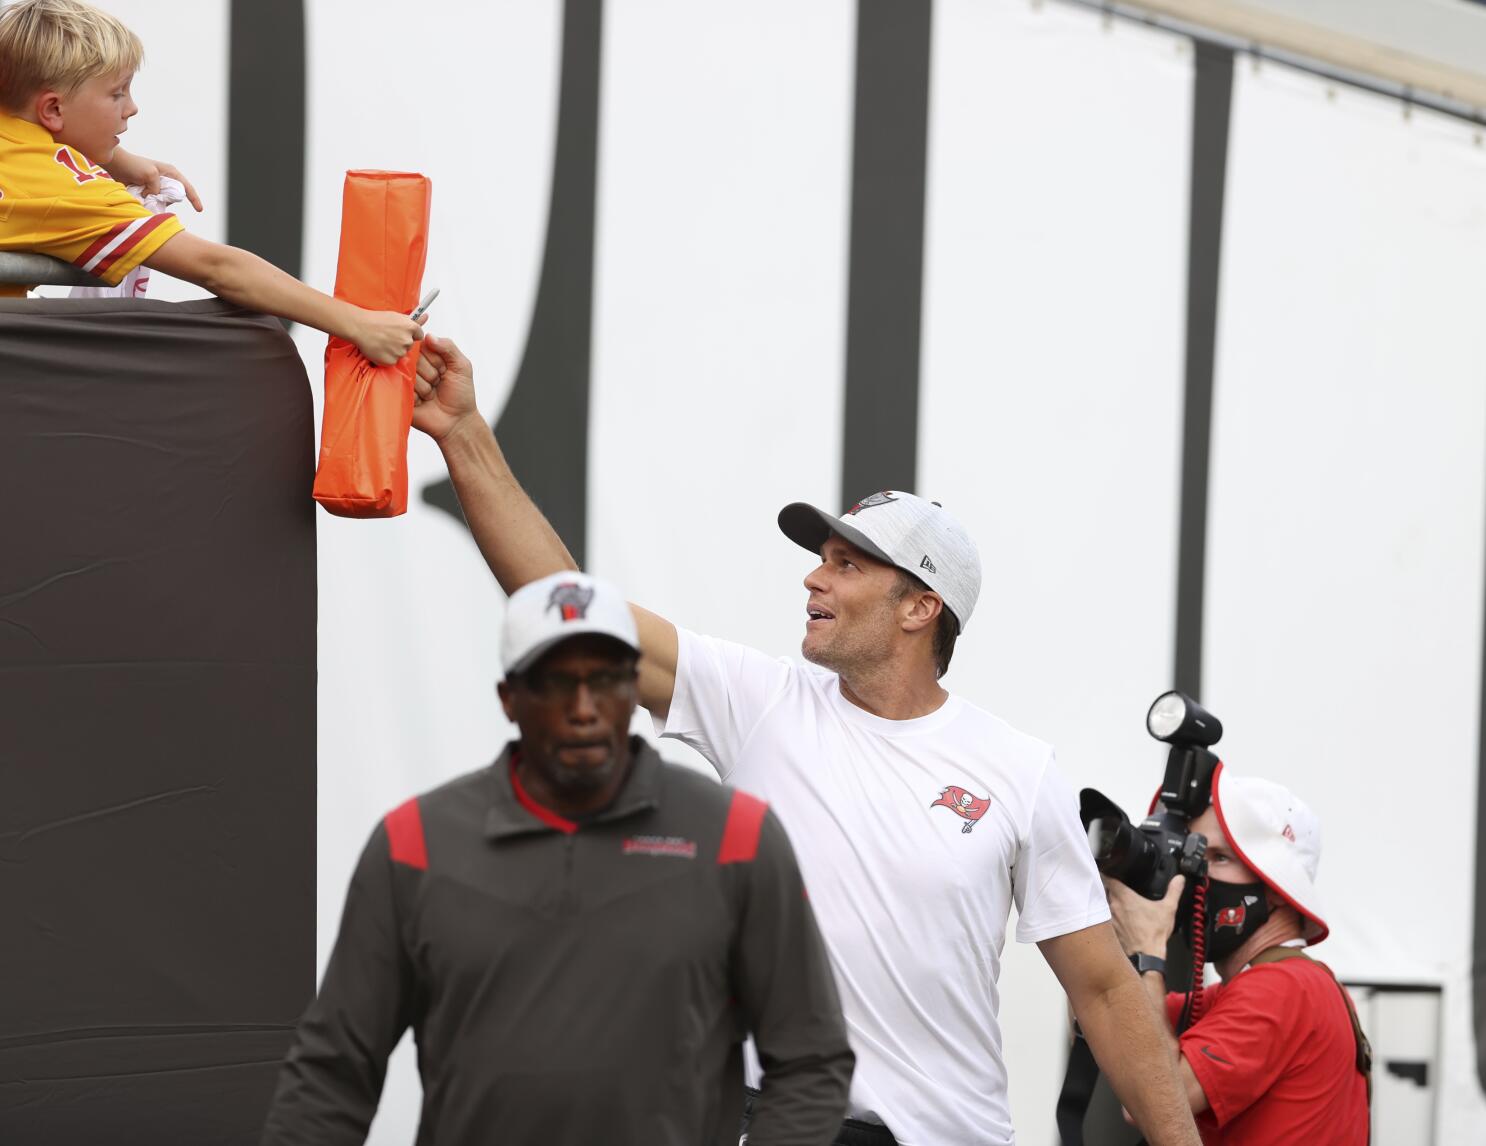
[{"x1": 72, "y1": 0, "x2": 1486, "y2": 1145}]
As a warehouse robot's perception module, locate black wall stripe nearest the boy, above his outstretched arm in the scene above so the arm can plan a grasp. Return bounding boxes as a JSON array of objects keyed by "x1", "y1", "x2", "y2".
[{"x1": 227, "y1": 0, "x2": 305, "y2": 278}]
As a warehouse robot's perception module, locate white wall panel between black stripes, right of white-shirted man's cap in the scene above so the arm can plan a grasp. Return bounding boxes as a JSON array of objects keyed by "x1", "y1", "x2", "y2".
[{"x1": 921, "y1": 0, "x2": 1192, "y2": 1143}]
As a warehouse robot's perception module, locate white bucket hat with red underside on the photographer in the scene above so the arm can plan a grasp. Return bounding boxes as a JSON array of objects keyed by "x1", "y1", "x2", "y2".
[{"x1": 1213, "y1": 764, "x2": 1330, "y2": 944}]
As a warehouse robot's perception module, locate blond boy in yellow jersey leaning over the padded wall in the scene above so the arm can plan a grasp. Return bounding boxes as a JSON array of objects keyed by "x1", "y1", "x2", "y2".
[{"x1": 0, "y1": 0, "x2": 422, "y2": 366}]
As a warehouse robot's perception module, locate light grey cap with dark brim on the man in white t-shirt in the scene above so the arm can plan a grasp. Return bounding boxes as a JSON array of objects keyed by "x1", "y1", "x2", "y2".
[{"x1": 779, "y1": 489, "x2": 981, "y2": 633}]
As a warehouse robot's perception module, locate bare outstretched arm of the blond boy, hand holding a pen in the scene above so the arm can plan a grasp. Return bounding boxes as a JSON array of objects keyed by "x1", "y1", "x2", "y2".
[{"x1": 144, "y1": 232, "x2": 424, "y2": 366}]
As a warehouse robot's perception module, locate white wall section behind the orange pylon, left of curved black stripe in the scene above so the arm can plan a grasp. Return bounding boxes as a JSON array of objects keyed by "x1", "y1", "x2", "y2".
[{"x1": 297, "y1": 0, "x2": 562, "y2": 1143}]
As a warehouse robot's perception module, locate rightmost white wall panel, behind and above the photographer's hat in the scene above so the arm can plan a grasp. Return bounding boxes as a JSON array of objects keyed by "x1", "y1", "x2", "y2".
[{"x1": 1204, "y1": 67, "x2": 1486, "y2": 1143}]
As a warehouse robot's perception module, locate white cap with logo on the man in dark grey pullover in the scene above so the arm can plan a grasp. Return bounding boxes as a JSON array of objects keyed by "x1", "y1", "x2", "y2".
[{"x1": 501, "y1": 571, "x2": 640, "y2": 676}]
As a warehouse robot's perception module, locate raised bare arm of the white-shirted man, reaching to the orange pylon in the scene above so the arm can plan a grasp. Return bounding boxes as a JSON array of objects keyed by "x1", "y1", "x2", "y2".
[{"x1": 413, "y1": 334, "x2": 679, "y2": 718}]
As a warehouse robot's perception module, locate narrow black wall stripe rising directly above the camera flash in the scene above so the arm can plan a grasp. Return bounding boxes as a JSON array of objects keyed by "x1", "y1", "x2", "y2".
[{"x1": 1175, "y1": 40, "x2": 1233, "y2": 697}]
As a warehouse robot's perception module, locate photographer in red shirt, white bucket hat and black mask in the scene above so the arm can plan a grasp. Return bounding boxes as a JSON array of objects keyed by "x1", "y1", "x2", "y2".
[{"x1": 1104, "y1": 765, "x2": 1370, "y2": 1146}]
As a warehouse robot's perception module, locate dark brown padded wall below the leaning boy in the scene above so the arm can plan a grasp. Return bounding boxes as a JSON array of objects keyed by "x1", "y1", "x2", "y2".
[{"x1": 0, "y1": 300, "x2": 315, "y2": 1146}]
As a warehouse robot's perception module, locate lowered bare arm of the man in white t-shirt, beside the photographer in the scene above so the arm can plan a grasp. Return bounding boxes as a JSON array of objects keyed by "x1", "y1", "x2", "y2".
[{"x1": 1037, "y1": 923, "x2": 1201, "y2": 1146}]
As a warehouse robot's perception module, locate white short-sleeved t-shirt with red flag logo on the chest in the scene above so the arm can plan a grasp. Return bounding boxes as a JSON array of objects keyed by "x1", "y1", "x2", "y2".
[{"x1": 661, "y1": 630, "x2": 1110, "y2": 1146}]
